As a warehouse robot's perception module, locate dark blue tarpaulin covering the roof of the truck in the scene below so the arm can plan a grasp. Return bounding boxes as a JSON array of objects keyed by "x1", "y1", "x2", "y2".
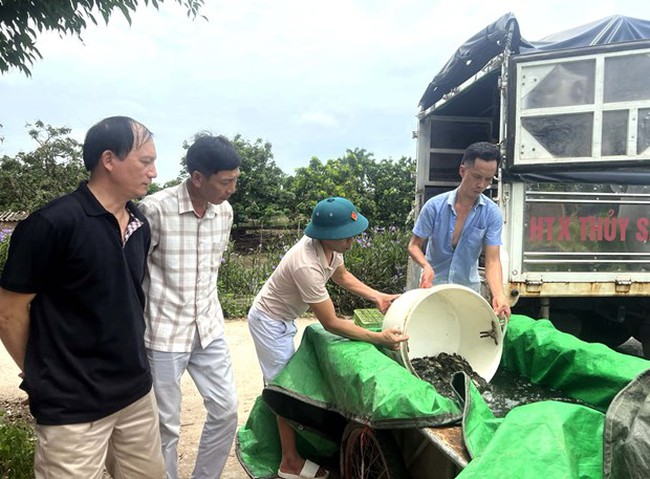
[{"x1": 419, "y1": 13, "x2": 650, "y2": 109}]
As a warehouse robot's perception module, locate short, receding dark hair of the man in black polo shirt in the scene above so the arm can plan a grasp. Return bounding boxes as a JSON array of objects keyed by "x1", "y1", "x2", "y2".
[{"x1": 83, "y1": 116, "x2": 153, "y2": 171}]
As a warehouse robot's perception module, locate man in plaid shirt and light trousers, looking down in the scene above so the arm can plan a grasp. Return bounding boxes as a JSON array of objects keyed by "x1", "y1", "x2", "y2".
[{"x1": 140, "y1": 135, "x2": 241, "y2": 479}]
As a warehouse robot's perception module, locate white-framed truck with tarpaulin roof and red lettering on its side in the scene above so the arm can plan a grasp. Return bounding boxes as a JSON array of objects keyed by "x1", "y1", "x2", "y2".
[{"x1": 407, "y1": 13, "x2": 650, "y2": 357}]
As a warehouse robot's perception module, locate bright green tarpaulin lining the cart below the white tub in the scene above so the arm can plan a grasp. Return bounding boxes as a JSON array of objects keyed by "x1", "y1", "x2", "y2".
[{"x1": 237, "y1": 315, "x2": 650, "y2": 479}]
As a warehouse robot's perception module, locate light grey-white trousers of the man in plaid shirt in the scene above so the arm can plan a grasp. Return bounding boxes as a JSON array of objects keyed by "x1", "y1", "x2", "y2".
[{"x1": 147, "y1": 335, "x2": 238, "y2": 479}]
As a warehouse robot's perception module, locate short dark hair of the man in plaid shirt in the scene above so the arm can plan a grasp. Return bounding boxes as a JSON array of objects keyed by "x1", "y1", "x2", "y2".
[{"x1": 186, "y1": 133, "x2": 241, "y2": 177}]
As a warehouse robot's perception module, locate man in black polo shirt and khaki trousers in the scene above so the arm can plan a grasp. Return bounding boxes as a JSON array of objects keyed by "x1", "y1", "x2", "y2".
[{"x1": 0, "y1": 117, "x2": 164, "y2": 479}]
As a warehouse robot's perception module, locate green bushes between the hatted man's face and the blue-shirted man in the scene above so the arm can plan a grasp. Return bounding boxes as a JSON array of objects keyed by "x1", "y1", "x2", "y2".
[{"x1": 328, "y1": 227, "x2": 411, "y2": 315}]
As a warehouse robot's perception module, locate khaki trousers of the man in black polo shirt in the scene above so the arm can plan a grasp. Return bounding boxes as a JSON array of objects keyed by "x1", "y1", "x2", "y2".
[{"x1": 34, "y1": 390, "x2": 165, "y2": 479}]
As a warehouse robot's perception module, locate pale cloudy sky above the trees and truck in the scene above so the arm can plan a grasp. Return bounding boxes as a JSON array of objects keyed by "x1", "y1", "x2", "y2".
[{"x1": 0, "y1": 0, "x2": 650, "y2": 183}]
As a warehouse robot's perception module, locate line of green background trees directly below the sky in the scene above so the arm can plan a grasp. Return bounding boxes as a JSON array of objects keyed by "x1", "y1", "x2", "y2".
[{"x1": 0, "y1": 120, "x2": 415, "y2": 232}]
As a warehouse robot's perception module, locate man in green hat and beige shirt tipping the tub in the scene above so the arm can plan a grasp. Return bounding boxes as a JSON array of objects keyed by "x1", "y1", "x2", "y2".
[{"x1": 248, "y1": 197, "x2": 408, "y2": 479}]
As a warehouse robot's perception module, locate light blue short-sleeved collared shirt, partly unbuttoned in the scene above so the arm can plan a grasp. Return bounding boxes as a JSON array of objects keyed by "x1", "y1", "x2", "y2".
[{"x1": 413, "y1": 188, "x2": 503, "y2": 291}]
